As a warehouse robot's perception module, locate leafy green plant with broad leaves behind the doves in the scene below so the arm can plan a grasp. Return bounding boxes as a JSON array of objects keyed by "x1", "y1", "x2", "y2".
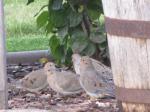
[{"x1": 28, "y1": 0, "x2": 107, "y2": 66}]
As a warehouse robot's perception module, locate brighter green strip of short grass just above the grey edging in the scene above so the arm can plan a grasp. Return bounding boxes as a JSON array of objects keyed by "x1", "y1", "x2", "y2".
[{"x1": 7, "y1": 35, "x2": 48, "y2": 51}]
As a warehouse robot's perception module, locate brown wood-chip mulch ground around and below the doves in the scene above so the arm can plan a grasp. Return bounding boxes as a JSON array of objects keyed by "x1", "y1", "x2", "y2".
[{"x1": 7, "y1": 63, "x2": 118, "y2": 112}]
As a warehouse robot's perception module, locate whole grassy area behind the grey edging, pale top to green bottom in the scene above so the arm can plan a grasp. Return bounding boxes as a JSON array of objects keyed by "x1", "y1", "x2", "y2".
[{"x1": 4, "y1": 0, "x2": 49, "y2": 51}]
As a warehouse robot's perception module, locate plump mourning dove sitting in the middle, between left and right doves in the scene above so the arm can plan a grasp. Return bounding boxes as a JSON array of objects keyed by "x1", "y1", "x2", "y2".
[{"x1": 44, "y1": 62, "x2": 83, "y2": 95}]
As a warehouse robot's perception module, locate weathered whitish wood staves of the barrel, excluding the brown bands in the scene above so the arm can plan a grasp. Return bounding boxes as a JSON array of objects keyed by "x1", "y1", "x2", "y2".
[{"x1": 103, "y1": 0, "x2": 150, "y2": 112}]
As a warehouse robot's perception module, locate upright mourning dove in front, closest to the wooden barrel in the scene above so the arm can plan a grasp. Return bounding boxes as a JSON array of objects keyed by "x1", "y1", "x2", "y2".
[{"x1": 79, "y1": 56, "x2": 114, "y2": 99}]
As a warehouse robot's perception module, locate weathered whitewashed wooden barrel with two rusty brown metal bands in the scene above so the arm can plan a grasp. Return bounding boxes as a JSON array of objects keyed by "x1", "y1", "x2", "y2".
[{"x1": 102, "y1": 0, "x2": 150, "y2": 112}]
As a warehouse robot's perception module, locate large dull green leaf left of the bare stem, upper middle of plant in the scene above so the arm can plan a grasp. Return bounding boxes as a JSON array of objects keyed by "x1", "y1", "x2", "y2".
[{"x1": 69, "y1": 11, "x2": 83, "y2": 27}]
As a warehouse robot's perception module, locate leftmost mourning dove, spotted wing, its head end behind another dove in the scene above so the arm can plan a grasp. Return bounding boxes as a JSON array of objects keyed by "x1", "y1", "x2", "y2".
[{"x1": 21, "y1": 69, "x2": 48, "y2": 93}]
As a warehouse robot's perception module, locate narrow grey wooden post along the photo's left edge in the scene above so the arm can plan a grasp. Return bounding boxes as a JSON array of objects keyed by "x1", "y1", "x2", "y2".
[{"x1": 0, "y1": 0, "x2": 8, "y2": 109}]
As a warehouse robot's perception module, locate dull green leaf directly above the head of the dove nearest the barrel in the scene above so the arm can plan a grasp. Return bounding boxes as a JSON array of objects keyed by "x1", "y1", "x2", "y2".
[{"x1": 82, "y1": 42, "x2": 96, "y2": 56}]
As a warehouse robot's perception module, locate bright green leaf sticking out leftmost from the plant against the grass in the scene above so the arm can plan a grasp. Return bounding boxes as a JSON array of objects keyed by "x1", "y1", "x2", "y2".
[{"x1": 36, "y1": 11, "x2": 49, "y2": 28}]
